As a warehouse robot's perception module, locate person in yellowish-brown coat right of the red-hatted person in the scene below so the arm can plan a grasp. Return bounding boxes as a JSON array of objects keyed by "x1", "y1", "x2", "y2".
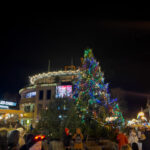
[{"x1": 73, "y1": 128, "x2": 83, "y2": 150}]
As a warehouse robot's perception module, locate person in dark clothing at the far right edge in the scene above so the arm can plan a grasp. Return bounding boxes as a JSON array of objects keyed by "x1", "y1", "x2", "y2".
[{"x1": 142, "y1": 131, "x2": 150, "y2": 150}]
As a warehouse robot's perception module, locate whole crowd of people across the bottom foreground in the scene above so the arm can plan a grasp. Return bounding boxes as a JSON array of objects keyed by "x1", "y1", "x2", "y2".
[{"x1": 0, "y1": 128, "x2": 150, "y2": 150}]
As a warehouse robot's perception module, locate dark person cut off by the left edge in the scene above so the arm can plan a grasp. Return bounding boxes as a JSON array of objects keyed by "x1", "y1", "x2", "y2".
[{"x1": 0, "y1": 130, "x2": 8, "y2": 150}]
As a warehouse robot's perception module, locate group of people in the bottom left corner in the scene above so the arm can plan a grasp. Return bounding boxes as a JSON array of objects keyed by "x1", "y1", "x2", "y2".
[{"x1": 0, "y1": 128, "x2": 48, "y2": 150}]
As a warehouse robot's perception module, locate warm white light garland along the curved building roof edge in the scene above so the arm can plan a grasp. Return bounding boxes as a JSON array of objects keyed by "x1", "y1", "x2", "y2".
[{"x1": 29, "y1": 70, "x2": 79, "y2": 84}]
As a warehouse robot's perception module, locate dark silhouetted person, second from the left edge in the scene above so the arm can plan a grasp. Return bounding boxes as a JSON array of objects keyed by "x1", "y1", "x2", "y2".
[{"x1": 8, "y1": 130, "x2": 20, "y2": 150}]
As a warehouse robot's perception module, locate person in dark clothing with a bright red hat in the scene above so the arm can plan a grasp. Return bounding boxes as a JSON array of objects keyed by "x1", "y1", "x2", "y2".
[{"x1": 64, "y1": 128, "x2": 72, "y2": 150}]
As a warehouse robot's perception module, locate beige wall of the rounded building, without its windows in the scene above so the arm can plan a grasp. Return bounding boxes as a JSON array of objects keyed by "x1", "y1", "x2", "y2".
[{"x1": 19, "y1": 71, "x2": 78, "y2": 125}]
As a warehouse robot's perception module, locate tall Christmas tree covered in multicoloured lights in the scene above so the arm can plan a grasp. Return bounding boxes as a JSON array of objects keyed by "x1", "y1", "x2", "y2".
[{"x1": 73, "y1": 49, "x2": 124, "y2": 125}]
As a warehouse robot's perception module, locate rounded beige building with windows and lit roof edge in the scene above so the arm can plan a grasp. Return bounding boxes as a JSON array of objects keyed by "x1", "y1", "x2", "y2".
[{"x1": 19, "y1": 70, "x2": 79, "y2": 127}]
